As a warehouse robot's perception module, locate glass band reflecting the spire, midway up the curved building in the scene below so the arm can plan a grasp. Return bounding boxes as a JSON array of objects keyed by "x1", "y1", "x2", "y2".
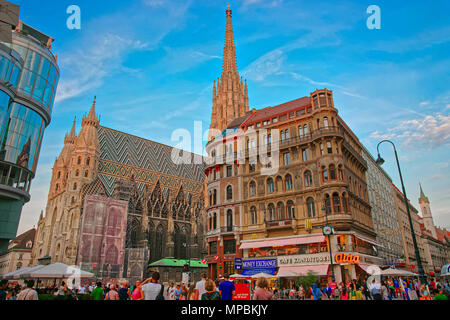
[{"x1": 0, "y1": 102, "x2": 45, "y2": 172}]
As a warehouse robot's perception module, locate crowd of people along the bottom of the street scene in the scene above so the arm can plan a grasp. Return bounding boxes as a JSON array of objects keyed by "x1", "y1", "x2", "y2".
[{"x1": 0, "y1": 272, "x2": 450, "y2": 300}]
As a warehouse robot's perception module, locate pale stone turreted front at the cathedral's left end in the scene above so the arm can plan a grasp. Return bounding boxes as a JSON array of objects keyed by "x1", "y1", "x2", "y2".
[{"x1": 32, "y1": 98, "x2": 99, "y2": 265}]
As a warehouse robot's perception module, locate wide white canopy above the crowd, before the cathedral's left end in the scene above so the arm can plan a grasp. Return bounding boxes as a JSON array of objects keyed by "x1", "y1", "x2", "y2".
[{"x1": 21, "y1": 262, "x2": 94, "y2": 279}]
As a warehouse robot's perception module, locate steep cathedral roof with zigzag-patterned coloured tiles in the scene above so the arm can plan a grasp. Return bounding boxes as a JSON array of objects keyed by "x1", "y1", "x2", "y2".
[{"x1": 98, "y1": 126, "x2": 205, "y2": 196}]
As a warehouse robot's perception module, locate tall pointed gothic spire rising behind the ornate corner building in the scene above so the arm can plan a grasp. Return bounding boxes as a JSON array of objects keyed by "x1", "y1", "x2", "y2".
[{"x1": 208, "y1": 4, "x2": 248, "y2": 140}]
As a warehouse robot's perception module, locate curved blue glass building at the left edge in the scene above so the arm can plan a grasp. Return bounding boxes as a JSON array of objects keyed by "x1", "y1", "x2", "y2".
[{"x1": 0, "y1": 13, "x2": 59, "y2": 252}]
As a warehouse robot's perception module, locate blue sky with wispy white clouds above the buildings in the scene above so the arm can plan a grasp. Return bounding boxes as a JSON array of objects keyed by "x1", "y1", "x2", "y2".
[{"x1": 13, "y1": 0, "x2": 450, "y2": 233}]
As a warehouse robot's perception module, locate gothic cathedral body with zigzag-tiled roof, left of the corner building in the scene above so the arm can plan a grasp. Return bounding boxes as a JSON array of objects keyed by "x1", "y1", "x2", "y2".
[{"x1": 32, "y1": 99, "x2": 205, "y2": 280}]
